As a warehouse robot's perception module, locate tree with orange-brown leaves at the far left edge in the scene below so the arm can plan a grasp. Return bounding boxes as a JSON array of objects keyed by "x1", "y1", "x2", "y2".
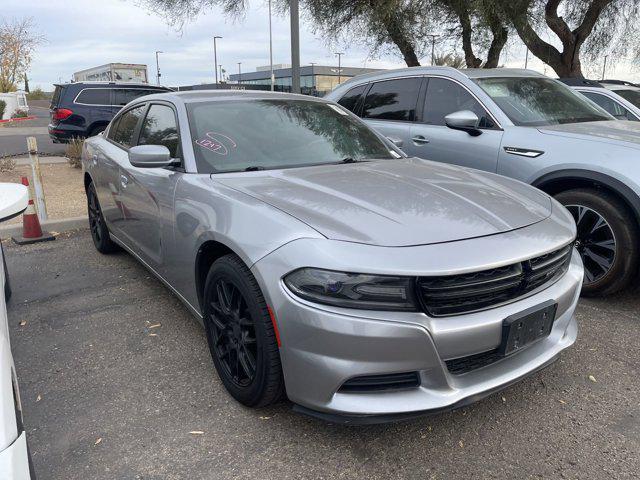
[{"x1": 0, "y1": 18, "x2": 44, "y2": 92}]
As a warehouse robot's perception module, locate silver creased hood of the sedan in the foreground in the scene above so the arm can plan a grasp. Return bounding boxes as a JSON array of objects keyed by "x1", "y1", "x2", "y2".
[{"x1": 212, "y1": 158, "x2": 551, "y2": 246}]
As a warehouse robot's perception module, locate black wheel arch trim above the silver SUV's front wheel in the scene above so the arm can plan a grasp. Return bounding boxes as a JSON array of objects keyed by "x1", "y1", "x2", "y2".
[{"x1": 532, "y1": 170, "x2": 640, "y2": 225}]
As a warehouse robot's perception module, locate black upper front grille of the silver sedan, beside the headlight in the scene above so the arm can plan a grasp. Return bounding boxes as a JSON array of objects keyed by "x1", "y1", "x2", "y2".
[{"x1": 418, "y1": 245, "x2": 572, "y2": 317}]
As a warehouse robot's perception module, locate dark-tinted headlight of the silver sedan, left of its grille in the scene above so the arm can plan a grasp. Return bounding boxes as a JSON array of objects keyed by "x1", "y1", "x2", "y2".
[{"x1": 284, "y1": 268, "x2": 417, "y2": 311}]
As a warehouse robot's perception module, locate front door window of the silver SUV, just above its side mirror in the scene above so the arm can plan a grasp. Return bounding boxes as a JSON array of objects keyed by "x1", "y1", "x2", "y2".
[{"x1": 424, "y1": 78, "x2": 496, "y2": 128}]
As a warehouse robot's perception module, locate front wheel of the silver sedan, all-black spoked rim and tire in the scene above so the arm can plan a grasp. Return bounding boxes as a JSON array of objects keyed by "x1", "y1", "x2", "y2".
[{"x1": 203, "y1": 255, "x2": 284, "y2": 407}]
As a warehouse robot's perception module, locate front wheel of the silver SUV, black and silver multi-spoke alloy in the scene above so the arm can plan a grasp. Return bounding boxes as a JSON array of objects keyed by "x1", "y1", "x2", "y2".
[{"x1": 555, "y1": 189, "x2": 640, "y2": 296}]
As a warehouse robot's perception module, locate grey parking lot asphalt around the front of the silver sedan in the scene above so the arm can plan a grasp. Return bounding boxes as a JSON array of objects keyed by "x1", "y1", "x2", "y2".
[{"x1": 5, "y1": 231, "x2": 640, "y2": 480}]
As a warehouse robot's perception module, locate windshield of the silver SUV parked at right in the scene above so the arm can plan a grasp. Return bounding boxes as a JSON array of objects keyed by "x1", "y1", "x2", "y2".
[{"x1": 475, "y1": 77, "x2": 613, "y2": 127}]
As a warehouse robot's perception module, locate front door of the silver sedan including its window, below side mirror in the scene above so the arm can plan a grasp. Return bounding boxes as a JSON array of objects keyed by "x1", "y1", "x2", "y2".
[{"x1": 120, "y1": 102, "x2": 184, "y2": 272}]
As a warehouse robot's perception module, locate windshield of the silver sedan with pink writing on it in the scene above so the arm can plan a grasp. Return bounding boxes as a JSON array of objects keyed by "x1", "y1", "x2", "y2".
[{"x1": 187, "y1": 99, "x2": 399, "y2": 173}]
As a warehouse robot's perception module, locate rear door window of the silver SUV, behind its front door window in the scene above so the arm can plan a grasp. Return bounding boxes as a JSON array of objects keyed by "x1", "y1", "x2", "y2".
[{"x1": 362, "y1": 78, "x2": 422, "y2": 121}]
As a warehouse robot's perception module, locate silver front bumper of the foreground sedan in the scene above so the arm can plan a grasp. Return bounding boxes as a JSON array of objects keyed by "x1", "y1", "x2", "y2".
[{"x1": 252, "y1": 223, "x2": 583, "y2": 423}]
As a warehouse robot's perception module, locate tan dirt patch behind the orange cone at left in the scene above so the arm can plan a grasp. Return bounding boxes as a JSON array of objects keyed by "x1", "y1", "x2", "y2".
[{"x1": 0, "y1": 163, "x2": 87, "y2": 223}]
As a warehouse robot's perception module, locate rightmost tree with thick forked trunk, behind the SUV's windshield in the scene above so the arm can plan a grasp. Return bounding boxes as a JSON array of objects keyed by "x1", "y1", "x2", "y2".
[{"x1": 501, "y1": 0, "x2": 640, "y2": 78}]
